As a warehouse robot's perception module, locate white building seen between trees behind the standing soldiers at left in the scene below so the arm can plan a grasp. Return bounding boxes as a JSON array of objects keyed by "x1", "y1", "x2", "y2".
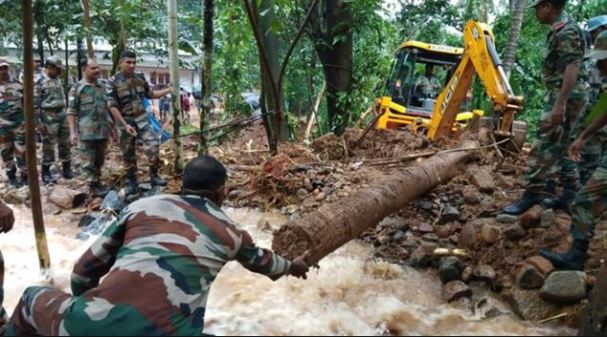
[{"x1": 0, "y1": 38, "x2": 200, "y2": 92}]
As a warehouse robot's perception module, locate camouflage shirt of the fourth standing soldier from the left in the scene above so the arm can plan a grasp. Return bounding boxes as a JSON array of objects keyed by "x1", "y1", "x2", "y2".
[{"x1": 108, "y1": 72, "x2": 152, "y2": 121}]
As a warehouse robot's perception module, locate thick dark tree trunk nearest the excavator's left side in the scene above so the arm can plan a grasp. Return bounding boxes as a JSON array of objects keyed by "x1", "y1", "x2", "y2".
[{"x1": 317, "y1": 0, "x2": 353, "y2": 134}]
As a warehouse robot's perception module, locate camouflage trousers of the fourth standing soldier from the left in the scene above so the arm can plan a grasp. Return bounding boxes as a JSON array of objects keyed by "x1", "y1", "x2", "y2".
[{"x1": 120, "y1": 121, "x2": 160, "y2": 177}]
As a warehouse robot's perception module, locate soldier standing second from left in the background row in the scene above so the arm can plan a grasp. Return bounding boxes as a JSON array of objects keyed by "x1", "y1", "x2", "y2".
[{"x1": 34, "y1": 56, "x2": 74, "y2": 184}]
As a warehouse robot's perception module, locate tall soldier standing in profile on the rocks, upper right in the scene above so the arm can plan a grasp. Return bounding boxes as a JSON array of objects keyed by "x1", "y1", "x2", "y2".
[{"x1": 503, "y1": 0, "x2": 588, "y2": 215}]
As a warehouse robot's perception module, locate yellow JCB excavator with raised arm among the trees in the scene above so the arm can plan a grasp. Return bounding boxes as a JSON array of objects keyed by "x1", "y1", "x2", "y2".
[{"x1": 376, "y1": 21, "x2": 527, "y2": 148}]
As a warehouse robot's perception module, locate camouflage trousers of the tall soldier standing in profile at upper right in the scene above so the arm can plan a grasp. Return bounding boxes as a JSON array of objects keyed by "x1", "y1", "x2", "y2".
[{"x1": 526, "y1": 89, "x2": 586, "y2": 194}]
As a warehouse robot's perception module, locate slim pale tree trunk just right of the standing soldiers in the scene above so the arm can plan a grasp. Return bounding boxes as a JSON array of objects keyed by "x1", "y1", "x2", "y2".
[{"x1": 167, "y1": 0, "x2": 183, "y2": 174}]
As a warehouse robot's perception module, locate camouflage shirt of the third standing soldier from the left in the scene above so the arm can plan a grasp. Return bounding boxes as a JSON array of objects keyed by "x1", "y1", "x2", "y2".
[{"x1": 67, "y1": 79, "x2": 111, "y2": 140}]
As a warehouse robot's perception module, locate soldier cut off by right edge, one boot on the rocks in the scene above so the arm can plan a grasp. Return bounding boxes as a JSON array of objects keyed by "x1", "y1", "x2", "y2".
[{"x1": 541, "y1": 32, "x2": 607, "y2": 270}]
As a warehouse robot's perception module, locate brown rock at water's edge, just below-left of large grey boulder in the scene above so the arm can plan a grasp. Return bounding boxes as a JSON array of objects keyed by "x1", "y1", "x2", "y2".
[{"x1": 504, "y1": 288, "x2": 561, "y2": 322}]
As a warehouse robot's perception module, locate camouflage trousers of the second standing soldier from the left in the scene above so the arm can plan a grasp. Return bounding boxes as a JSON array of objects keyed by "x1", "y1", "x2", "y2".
[{"x1": 42, "y1": 111, "x2": 72, "y2": 166}]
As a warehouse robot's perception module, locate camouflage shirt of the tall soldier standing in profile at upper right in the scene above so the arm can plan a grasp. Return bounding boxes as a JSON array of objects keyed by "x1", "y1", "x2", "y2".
[{"x1": 542, "y1": 13, "x2": 586, "y2": 88}]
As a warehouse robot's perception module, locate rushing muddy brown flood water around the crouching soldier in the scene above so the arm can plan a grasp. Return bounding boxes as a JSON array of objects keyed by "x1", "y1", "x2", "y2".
[{"x1": 0, "y1": 203, "x2": 575, "y2": 336}]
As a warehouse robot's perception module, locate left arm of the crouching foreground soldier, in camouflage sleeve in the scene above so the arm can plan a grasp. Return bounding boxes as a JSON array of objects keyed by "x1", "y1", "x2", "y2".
[{"x1": 71, "y1": 213, "x2": 130, "y2": 296}]
